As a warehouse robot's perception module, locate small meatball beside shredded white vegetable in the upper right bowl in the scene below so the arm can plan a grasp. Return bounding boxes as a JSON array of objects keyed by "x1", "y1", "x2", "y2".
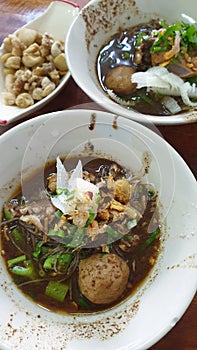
[{"x1": 105, "y1": 66, "x2": 136, "y2": 96}]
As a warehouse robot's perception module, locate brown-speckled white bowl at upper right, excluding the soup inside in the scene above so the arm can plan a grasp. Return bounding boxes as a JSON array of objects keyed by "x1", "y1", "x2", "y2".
[{"x1": 66, "y1": 0, "x2": 197, "y2": 124}]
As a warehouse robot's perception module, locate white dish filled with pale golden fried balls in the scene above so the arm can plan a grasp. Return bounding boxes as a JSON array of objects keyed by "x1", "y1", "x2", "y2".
[{"x1": 0, "y1": 1, "x2": 78, "y2": 124}]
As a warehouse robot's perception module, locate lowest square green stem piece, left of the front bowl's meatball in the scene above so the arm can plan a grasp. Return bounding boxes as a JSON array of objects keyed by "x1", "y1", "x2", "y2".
[{"x1": 45, "y1": 281, "x2": 69, "y2": 302}]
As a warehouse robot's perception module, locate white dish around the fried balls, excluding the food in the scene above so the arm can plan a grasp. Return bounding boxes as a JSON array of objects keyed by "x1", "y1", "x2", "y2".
[{"x1": 0, "y1": 0, "x2": 79, "y2": 125}]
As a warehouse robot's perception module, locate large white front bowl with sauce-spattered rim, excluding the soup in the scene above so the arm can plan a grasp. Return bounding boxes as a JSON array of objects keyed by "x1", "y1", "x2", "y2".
[{"x1": 0, "y1": 110, "x2": 197, "y2": 350}]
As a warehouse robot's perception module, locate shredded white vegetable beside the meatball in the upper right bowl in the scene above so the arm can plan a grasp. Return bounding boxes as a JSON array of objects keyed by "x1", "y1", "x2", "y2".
[{"x1": 131, "y1": 67, "x2": 197, "y2": 107}]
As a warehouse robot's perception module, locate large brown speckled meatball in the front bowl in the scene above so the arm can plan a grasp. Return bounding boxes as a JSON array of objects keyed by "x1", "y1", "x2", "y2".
[{"x1": 78, "y1": 253, "x2": 129, "y2": 304}]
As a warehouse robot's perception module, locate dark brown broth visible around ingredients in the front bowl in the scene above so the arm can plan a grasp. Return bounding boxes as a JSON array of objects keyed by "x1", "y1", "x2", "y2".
[{"x1": 1, "y1": 158, "x2": 160, "y2": 313}]
